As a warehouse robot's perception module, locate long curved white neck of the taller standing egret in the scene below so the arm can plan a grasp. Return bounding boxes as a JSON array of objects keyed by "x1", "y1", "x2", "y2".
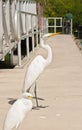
[{"x1": 41, "y1": 39, "x2": 52, "y2": 64}]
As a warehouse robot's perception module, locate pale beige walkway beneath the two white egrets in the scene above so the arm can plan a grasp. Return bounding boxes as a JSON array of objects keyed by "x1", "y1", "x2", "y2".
[{"x1": 0, "y1": 35, "x2": 82, "y2": 130}]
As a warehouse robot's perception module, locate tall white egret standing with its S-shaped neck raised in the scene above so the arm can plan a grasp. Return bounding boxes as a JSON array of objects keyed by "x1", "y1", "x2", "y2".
[{"x1": 23, "y1": 33, "x2": 56, "y2": 107}]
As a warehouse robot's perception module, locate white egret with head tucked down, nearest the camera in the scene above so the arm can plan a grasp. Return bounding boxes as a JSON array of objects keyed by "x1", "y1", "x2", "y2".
[{"x1": 3, "y1": 92, "x2": 32, "y2": 130}]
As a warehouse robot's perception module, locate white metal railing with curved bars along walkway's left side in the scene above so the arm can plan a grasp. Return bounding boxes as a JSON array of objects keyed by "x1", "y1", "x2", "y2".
[{"x1": 0, "y1": 0, "x2": 39, "y2": 66}]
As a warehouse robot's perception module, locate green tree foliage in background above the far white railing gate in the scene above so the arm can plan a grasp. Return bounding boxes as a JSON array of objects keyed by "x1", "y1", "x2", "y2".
[{"x1": 36, "y1": 0, "x2": 82, "y2": 27}]
